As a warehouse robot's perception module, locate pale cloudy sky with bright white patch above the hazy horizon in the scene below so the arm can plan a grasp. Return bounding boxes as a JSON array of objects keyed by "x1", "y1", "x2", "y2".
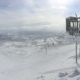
[{"x1": 0, "y1": 0, "x2": 80, "y2": 31}]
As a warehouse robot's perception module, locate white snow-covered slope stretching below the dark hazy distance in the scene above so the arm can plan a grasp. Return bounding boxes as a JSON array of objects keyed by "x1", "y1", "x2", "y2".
[{"x1": 0, "y1": 30, "x2": 80, "y2": 80}]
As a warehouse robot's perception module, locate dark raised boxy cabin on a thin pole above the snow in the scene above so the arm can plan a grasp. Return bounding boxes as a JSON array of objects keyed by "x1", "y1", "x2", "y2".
[{"x1": 66, "y1": 17, "x2": 80, "y2": 35}]
